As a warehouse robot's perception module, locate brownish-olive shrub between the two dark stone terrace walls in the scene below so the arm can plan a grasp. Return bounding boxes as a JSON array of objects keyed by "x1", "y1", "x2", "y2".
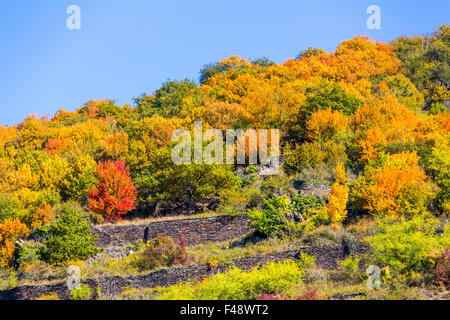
[{"x1": 140, "y1": 235, "x2": 188, "y2": 270}]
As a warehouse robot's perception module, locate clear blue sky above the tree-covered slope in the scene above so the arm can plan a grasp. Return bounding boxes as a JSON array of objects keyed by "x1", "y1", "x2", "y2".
[{"x1": 0, "y1": 0, "x2": 450, "y2": 125}]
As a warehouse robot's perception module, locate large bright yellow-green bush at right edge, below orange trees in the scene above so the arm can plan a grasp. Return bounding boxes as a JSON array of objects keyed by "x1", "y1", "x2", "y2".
[{"x1": 365, "y1": 217, "x2": 450, "y2": 280}]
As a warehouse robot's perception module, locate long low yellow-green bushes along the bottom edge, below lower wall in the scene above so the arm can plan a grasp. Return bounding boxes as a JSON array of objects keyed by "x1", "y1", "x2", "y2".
[{"x1": 156, "y1": 260, "x2": 309, "y2": 300}]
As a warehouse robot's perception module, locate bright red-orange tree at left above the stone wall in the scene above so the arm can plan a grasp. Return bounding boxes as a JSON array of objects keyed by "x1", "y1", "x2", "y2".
[{"x1": 88, "y1": 161, "x2": 137, "y2": 221}]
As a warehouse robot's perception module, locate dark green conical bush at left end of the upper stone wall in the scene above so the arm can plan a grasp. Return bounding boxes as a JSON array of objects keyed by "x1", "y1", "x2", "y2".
[{"x1": 39, "y1": 205, "x2": 102, "y2": 263}]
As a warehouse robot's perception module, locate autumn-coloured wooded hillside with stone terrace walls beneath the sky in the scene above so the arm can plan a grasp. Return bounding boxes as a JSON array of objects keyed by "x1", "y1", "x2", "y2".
[{"x1": 0, "y1": 25, "x2": 450, "y2": 300}]
